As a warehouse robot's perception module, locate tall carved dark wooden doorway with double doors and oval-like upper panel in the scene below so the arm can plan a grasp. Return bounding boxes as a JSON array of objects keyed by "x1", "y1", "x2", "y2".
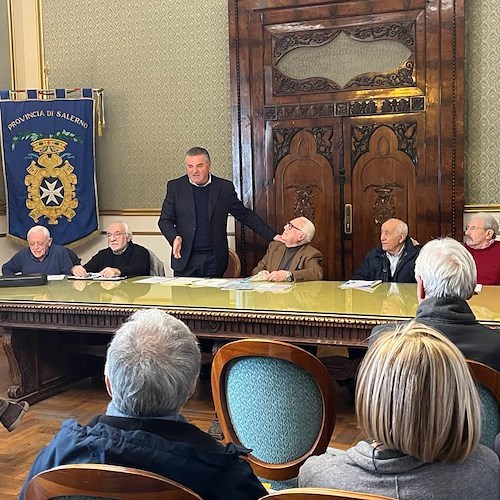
[{"x1": 229, "y1": 0, "x2": 463, "y2": 279}]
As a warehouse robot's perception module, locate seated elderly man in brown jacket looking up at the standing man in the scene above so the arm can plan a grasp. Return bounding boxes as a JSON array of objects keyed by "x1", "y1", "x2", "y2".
[{"x1": 252, "y1": 217, "x2": 323, "y2": 281}]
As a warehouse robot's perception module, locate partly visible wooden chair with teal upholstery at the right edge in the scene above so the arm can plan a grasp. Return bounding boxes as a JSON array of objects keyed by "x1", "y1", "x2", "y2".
[{"x1": 467, "y1": 359, "x2": 500, "y2": 448}]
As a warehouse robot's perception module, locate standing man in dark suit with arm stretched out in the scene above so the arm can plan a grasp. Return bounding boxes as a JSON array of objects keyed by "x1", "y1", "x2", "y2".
[{"x1": 158, "y1": 147, "x2": 281, "y2": 277}]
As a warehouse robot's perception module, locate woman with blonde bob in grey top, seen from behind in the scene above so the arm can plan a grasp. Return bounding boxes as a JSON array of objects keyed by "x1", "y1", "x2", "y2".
[{"x1": 299, "y1": 322, "x2": 500, "y2": 500}]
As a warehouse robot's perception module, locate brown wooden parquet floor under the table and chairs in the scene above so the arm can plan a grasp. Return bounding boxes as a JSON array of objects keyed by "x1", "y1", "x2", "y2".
[{"x1": 0, "y1": 344, "x2": 362, "y2": 500}]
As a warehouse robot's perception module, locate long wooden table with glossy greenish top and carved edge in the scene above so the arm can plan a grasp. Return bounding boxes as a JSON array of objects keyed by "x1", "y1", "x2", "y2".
[{"x1": 0, "y1": 278, "x2": 500, "y2": 403}]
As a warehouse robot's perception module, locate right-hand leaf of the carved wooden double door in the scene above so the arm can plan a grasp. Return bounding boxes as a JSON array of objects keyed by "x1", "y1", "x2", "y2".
[{"x1": 344, "y1": 113, "x2": 426, "y2": 275}]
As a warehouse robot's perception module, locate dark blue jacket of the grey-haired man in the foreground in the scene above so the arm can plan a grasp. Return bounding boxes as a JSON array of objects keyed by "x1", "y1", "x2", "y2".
[{"x1": 21, "y1": 415, "x2": 266, "y2": 500}]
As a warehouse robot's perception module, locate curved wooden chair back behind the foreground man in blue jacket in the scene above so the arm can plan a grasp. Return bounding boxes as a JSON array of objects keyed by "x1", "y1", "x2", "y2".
[{"x1": 24, "y1": 464, "x2": 201, "y2": 500}]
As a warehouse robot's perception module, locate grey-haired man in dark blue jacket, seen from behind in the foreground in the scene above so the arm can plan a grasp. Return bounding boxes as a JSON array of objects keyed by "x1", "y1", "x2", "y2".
[{"x1": 21, "y1": 309, "x2": 266, "y2": 500}]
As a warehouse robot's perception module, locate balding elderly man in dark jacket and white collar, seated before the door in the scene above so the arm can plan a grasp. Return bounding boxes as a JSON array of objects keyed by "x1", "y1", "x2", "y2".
[{"x1": 352, "y1": 219, "x2": 420, "y2": 283}]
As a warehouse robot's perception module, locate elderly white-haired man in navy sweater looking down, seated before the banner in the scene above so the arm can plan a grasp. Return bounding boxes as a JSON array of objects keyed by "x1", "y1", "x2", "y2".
[{"x1": 2, "y1": 226, "x2": 73, "y2": 275}]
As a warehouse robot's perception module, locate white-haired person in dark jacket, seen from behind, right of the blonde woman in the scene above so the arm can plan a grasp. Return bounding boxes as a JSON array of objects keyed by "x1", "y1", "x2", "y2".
[{"x1": 369, "y1": 238, "x2": 500, "y2": 371}]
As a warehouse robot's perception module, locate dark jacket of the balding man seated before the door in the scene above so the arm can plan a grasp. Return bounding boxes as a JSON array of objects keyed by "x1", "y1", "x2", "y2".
[{"x1": 352, "y1": 237, "x2": 421, "y2": 283}]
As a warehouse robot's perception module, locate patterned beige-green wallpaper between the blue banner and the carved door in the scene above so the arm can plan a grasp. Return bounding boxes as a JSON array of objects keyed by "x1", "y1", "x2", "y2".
[{"x1": 42, "y1": 0, "x2": 232, "y2": 210}]
